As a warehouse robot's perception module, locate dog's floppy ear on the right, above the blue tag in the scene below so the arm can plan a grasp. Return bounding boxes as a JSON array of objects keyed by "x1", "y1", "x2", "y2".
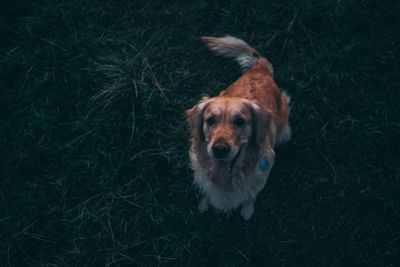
[{"x1": 247, "y1": 101, "x2": 272, "y2": 147}]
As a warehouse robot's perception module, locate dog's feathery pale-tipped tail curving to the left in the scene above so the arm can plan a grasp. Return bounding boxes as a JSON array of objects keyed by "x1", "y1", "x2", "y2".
[{"x1": 201, "y1": 36, "x2": 273, "y2": 74}]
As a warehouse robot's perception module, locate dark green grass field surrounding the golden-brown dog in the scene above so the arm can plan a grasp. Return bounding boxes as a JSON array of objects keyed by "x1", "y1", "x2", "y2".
[{"x1": 0, "y1": 0, "x2": 400, "y2": 266}]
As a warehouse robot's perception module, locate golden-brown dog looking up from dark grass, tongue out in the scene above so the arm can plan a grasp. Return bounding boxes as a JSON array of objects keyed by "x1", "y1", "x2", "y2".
[{"x1": 186, "y1": 36, "x2": 291, "y2": 220}]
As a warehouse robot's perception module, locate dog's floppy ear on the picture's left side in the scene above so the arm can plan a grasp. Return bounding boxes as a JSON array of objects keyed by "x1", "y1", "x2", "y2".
[{"x1": 186, "y1": 96, "x2": 210, "y2": 144}]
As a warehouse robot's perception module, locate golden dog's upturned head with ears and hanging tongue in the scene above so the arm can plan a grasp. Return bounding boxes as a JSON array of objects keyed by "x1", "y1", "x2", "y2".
[{"x1": 187, "y1": 96, "x2": 269, "y2": 184}]
